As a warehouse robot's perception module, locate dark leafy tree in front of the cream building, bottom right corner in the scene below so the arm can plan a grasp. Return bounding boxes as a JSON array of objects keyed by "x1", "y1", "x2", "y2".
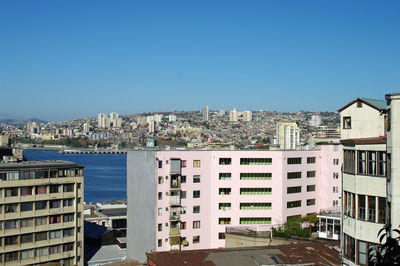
[{"x1": 368, "y1": 225, "x2": 400, "y2": 266}]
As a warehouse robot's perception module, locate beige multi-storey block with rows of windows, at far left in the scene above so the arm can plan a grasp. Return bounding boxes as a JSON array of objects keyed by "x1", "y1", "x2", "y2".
[{"x1": 0, "y1": 161, "x2": 84, "y2": 265}]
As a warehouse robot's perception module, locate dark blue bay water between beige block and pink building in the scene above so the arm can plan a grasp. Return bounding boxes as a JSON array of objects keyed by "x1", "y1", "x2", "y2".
[{"x1": 24, "y1": 150, "x2": 126, "y2": 202}]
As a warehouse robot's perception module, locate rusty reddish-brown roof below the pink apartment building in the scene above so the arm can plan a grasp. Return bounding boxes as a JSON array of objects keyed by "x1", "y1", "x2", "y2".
[{"x1": 147, "y1": 242, "x2": 341, "y2": 266}]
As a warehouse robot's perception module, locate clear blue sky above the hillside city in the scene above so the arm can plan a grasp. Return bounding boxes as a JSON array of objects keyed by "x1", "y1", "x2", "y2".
[{"x1": 0, "y1": 0, "x2": 400, "y2": 121}]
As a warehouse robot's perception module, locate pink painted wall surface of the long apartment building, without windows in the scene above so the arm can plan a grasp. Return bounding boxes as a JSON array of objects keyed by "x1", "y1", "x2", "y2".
[{"x1": 155, "y1": 145, "x2": 341, "y2": 251}]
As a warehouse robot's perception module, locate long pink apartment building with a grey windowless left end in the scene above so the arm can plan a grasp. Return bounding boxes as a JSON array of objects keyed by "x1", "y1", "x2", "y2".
[{"x1": 127, "y1": 143, "x2": 341, "y2": 261}]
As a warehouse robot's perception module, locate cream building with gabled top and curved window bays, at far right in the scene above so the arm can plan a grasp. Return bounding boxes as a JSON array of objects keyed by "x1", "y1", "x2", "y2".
[{"x1": 338, "y1": 95, "x2": 390, "y2": 265}]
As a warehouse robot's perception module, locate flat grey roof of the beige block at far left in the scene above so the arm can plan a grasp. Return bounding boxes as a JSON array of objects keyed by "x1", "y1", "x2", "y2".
[{"x1": 0, "y1": 160, "x2": 83, "y2": 170}]
